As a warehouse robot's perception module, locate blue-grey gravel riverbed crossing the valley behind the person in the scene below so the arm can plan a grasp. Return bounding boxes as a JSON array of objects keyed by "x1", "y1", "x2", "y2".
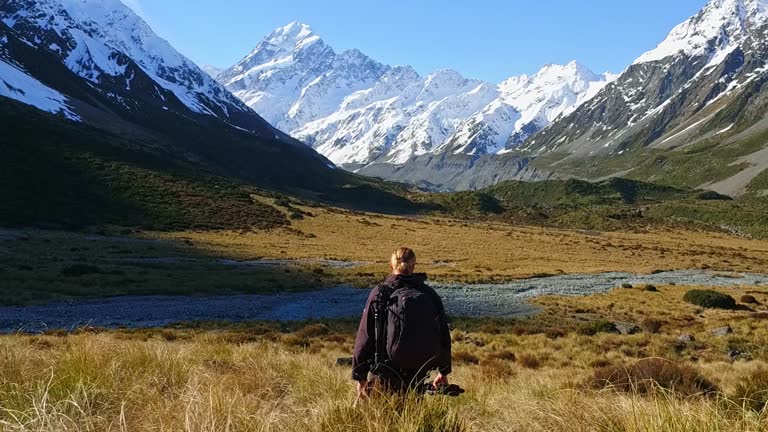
[{"x1": 0, "y1": 270, "x2": 768, "y2": 333}]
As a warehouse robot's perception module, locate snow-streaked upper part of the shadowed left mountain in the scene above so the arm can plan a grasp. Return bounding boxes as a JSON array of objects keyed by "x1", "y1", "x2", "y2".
[{"x1": 0, "y1": 0, "x2": 275, "y2": 136}]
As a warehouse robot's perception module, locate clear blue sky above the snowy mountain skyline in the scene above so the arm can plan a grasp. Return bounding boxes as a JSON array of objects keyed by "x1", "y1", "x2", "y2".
[{"x1": 123, "y1": 0, "x2": 706, "y2": 82}]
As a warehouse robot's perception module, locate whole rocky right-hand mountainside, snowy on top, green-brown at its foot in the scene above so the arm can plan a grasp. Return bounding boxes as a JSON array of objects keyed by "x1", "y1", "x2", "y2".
[{"x1": 521, "y1": 0, "x2": 768, "y2": 194}]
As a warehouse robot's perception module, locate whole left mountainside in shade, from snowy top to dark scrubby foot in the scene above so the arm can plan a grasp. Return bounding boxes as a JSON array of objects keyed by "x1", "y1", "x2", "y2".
[{"x1": 0, "y1": 0, "x2": 420, "y2": 229}]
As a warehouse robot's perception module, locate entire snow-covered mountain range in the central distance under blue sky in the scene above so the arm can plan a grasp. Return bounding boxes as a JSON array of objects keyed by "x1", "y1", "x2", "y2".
[{"x1": 217, "y1": 22, "x2": 611, "y2": 167}]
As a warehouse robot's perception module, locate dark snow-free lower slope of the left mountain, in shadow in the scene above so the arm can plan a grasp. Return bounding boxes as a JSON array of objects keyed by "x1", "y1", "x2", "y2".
[{"x1": 0, "y1": 99, "x2": 415, "y2": 230}]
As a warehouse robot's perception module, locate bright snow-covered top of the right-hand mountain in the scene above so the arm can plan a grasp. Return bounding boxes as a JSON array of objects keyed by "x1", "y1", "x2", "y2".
[{"x1": 634, "y1": 0, "x2": 768, "y2": 64}]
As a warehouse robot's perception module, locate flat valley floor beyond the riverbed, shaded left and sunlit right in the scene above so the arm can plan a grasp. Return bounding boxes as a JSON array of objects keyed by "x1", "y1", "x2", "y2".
[{"x1": 0, "y1": 198, "x2": 768, "y2": 305}]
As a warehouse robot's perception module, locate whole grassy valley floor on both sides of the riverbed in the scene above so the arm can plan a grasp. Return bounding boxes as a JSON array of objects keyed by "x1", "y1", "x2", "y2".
[{"x1": 0, "y1": 198, "x2": 768, "y2": 431}]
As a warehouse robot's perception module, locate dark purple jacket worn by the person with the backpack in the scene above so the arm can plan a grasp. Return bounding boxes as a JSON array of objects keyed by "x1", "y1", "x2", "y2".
[{"x1": 352, "y1": 273, "x2": 451, "y2": 381}]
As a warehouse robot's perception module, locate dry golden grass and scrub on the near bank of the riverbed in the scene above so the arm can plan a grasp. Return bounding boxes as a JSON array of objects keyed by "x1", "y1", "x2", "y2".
[{"x1": 0, "y1": 286, "x2": 768, "y2": 432}]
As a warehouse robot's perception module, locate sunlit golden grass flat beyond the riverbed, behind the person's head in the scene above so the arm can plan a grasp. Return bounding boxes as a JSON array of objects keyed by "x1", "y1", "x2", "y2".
[{"x1": 149, "y1": 202, "x2": 768, "y2": 281}]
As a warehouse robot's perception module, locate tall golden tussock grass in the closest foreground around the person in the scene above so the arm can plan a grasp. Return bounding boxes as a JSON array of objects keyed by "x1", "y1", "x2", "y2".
[{"x1": 0, "y1": 334, "x2": 768, "y2": 432}]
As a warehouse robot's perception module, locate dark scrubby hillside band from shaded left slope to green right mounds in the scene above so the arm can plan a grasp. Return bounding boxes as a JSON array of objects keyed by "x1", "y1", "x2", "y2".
[{"x1": 0, "y1": 93, "x2": 768, "y2": 240}]
